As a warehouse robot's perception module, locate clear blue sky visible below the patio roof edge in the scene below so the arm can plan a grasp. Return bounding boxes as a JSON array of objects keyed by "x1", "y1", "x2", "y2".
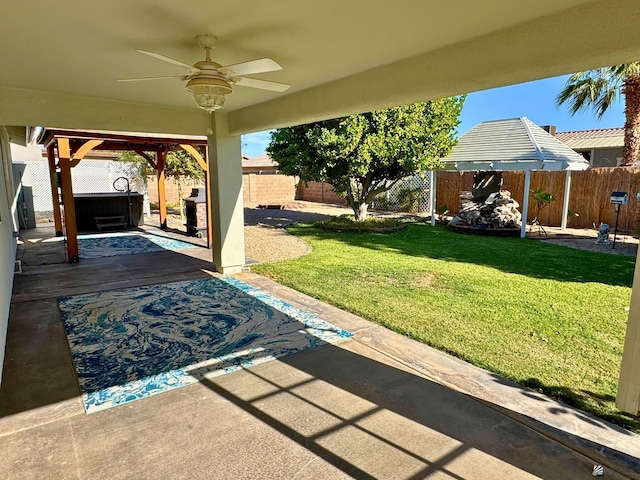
[{"x1": 242, "y1": 76, "x2": 624, "y2": 157}]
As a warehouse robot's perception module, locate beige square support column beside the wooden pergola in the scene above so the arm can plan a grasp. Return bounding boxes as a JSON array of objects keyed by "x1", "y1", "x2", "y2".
[{"x1": 207, "y1": 113, "x2": 245, "y2": 274}]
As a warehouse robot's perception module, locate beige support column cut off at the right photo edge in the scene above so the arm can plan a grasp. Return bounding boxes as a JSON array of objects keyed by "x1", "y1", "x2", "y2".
[{"x1": 616, "y1": 246, "x2": 640, "y2": 415}]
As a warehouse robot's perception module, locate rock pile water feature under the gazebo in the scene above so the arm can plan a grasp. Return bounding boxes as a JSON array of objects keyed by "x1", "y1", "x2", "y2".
[{"x1": 449, "y1": 172, "x2": 522, "y2": 235}]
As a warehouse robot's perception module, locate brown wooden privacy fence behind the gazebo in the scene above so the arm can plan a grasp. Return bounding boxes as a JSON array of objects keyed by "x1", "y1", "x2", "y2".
[{"x1": 437, "y1": 167, "x2": 640, "y2": 232}]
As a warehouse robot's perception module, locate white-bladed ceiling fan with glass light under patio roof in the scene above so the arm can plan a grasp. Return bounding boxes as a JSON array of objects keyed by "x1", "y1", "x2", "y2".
[{"x1": 118, "y1": 34, "x2": 290, "y2": 113}]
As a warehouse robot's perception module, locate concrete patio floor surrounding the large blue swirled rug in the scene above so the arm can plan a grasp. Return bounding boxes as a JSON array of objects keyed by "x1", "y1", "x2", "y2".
[{"x1": 0, "y1": 226, "x2": 640, "y2": 479}]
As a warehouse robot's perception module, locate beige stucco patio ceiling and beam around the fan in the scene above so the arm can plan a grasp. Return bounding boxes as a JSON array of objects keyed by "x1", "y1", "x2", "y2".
[{"x1": 0, "y1": 0, "x2": 640, "y2": 134}]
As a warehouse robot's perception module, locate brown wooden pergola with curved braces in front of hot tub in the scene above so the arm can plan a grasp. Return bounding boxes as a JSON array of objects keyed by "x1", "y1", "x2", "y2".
[{"x1": 39, "y1": 128, "x2": 212, "y2": 263}]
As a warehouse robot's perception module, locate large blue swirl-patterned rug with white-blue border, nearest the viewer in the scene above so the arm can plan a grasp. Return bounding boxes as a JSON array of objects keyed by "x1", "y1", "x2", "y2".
[{"x1": 58, "y1": 277, "x2": 353, "y2": 413}]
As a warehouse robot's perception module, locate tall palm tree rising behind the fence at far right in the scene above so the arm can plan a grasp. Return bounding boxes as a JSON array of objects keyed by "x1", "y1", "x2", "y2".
[{"x1": 556, "y1": 62, "x2": 640, "y2": 166}]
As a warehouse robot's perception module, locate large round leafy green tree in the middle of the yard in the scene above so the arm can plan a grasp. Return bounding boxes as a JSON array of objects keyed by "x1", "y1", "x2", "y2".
[{"x1": 267, "y1": 96, "x2": 465, "y2": 221}]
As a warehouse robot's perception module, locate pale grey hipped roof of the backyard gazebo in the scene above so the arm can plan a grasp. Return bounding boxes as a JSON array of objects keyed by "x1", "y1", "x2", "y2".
[{"x1": 442, "y1": 117, "x2": 589, "y2": 171}]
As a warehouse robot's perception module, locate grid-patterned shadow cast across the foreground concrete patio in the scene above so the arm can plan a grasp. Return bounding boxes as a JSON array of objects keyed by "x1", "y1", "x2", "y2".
[{"x1": 192, "y1": 344, "x2": 636, "y2": 480}]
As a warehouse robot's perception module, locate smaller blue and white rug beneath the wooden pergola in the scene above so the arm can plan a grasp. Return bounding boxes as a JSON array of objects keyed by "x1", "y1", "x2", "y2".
[{"x1": 78, "y1": 232, "x2": 198, "y2": 258}]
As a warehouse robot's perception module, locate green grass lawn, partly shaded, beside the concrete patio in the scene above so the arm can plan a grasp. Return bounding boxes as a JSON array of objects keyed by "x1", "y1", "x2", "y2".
[{"x1": 252, "y1": 224, "x2": 640, "y2": 431}]
